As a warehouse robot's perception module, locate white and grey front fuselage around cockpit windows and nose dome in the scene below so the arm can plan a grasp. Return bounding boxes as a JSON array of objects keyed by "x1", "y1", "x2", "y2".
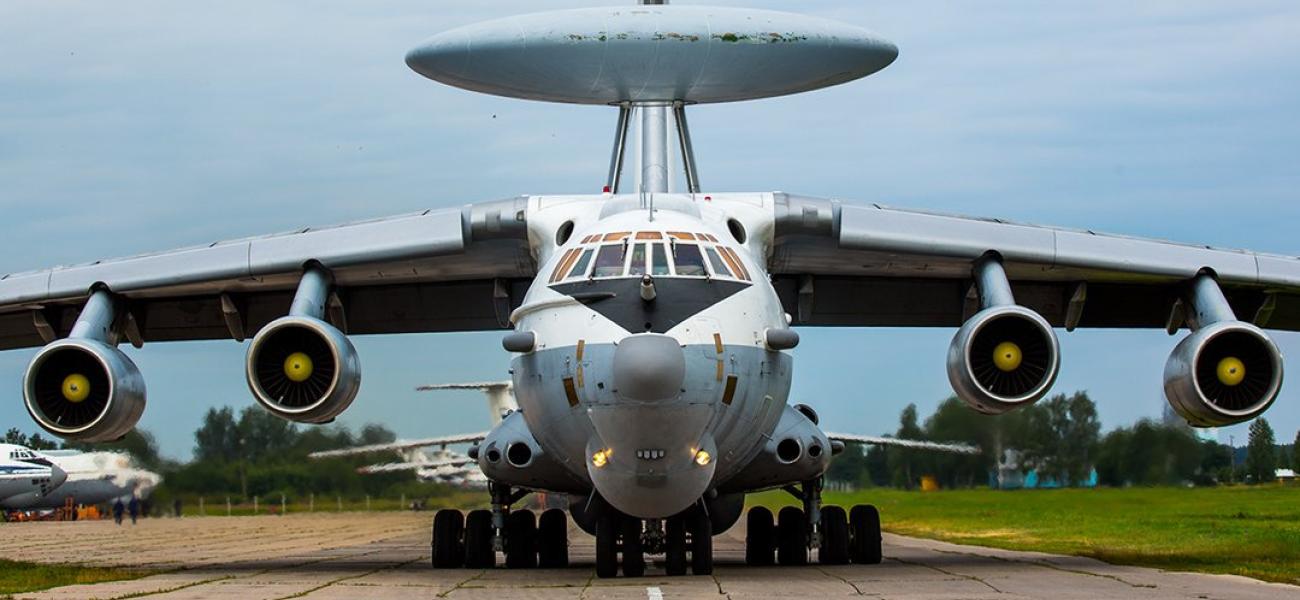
[{"x1": 480, "y1": 194, "x2": 792, "y2": 517}]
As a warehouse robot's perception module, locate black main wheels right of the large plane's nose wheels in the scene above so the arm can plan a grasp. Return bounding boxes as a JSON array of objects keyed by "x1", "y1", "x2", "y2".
[{"x1": 745, "y1": 479, "x2": 883, "y2": 566}]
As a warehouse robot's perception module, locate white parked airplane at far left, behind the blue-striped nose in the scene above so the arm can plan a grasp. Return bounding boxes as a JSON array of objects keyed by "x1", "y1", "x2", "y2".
[{"x1": 0, "y1": 449, "x2": 163, "y2": 510}]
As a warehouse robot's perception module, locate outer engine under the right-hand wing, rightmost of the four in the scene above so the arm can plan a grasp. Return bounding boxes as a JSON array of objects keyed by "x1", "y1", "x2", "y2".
[{"x1": 1165, "y1": 321, "x2": 1282, "y2": 427}]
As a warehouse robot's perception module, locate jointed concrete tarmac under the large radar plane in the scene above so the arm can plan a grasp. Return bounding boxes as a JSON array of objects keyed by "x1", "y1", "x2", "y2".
[{"x1": 0, "y1": 513, "x2": 1300, "y2": 600}]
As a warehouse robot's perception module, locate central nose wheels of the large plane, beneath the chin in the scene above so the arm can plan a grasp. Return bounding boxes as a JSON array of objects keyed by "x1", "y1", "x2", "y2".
[{"x1": 595, "y1": 508, "x2": 714, "y2": 579}]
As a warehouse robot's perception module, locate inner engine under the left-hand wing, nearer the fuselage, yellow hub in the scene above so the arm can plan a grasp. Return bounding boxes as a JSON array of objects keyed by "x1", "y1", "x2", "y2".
[{"x1": 244, "y1": 316, "x2": 361, "y2": 423}]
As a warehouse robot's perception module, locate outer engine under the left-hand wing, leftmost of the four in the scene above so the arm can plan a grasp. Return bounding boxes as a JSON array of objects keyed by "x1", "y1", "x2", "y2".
[{"x1": 22, "y1": 338, "x2": 144, "y2": 442}]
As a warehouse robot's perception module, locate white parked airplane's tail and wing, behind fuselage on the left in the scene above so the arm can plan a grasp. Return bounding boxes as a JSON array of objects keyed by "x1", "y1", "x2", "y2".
[{"x1": 308, "y1": 381, "x2": 519, "y2": 488}]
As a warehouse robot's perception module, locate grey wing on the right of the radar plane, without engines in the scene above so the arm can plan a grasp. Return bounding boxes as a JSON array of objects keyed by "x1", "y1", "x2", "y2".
[{"x1": 770, "y1": 195, "x2": 1300, "y2": 331}]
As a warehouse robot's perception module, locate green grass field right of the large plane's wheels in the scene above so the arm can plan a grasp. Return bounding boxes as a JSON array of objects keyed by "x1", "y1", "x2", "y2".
[{"x1": 750, "y1": 486, "x2": 1300, "y2": 583}]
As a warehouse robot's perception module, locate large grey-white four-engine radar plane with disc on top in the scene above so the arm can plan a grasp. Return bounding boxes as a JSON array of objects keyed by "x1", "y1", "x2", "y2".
[{"x1": 0, "y1": 1, "x2": 1300, "y2": 578}]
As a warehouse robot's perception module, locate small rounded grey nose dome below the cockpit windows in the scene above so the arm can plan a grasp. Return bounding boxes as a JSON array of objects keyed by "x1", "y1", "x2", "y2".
[{"x1": 614, "y1": 334, "x2": 686, "y2": 401}]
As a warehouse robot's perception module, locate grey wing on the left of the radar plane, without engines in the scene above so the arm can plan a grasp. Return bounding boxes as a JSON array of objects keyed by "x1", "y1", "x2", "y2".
[{"x1": 0, "y1": 197, "x2": 537, "y2": 349}]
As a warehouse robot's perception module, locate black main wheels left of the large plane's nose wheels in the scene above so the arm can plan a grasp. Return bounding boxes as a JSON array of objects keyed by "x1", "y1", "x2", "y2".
[{"x1": 433, "y1": 483, "x2": 568, "y2": 569}]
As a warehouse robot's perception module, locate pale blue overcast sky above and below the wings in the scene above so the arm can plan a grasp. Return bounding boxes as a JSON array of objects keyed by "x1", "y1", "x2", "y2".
[{"x1": 0, "y1": 0, "x2": 1300, "y2": 457}]
